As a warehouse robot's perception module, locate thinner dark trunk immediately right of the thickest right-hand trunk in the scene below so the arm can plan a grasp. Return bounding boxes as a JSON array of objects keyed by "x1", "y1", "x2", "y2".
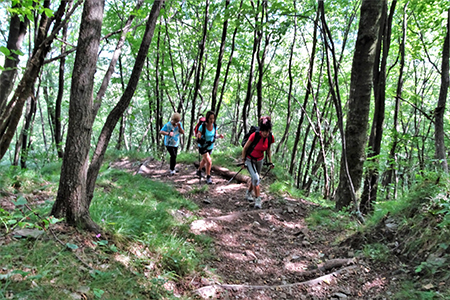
[{"x1": 360, "y1": 0, "x2": 397, "y2": 213}]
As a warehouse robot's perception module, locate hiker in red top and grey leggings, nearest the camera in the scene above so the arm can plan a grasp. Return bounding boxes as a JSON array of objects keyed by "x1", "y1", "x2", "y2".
[{"x1": 242, "y1": 116, "x2": 275, "y2": 209}]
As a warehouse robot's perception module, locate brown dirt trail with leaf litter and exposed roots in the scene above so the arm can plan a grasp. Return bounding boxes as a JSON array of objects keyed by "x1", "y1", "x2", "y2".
[{"x1": 114, "y1": 157, "x2": 401, "y2": 300}]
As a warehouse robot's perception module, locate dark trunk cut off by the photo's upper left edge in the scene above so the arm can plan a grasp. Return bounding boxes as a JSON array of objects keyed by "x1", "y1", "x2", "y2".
[{"x1": 0, "y1": 4, "x2": 29, "y2": 115}]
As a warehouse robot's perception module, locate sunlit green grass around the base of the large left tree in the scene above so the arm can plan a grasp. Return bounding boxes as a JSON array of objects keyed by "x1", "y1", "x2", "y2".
[{"x1": 0, "y1": 164, "x2": 211, "y2": 299}]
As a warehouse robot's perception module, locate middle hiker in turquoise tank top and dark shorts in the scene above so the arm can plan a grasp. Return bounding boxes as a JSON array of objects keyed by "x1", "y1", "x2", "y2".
[{"x1": 196, "y1": 111, "x2": 223, "y2": 184}]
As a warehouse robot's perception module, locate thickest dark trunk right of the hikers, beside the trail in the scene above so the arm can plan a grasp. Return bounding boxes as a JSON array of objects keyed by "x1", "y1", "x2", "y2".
[{"x1": 336, "y1": 0, "x2": 382, "y2": 210}]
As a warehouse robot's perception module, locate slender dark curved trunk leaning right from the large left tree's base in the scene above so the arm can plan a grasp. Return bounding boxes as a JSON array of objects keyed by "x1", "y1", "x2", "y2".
[{"x1": 87, "y1": 0, "x2": 164, "y2": 206}]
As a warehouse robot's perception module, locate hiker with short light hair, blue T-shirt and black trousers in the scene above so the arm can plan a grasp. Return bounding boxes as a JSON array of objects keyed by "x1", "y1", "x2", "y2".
[{"x1": 159, "y1": 113, "x2": 184, "y2": 176}]
